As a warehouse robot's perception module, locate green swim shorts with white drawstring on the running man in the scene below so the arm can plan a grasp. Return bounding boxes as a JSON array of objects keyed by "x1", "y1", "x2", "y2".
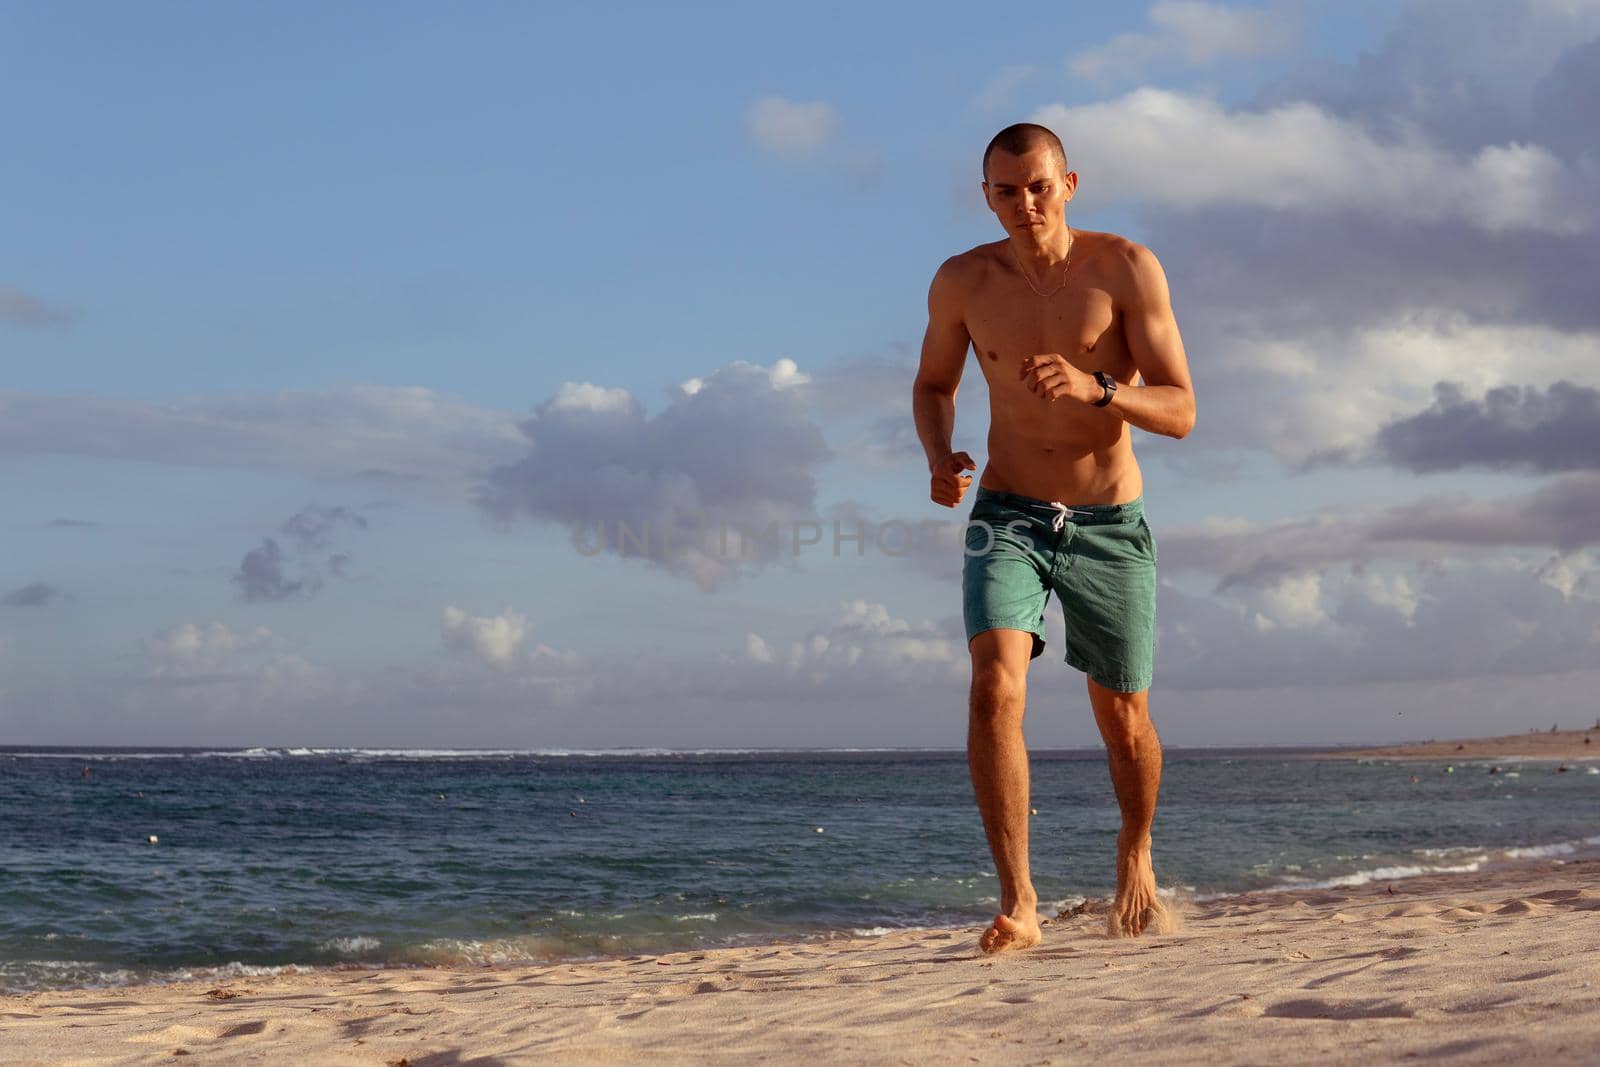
[{"x1": 962, "y1": 486, "x2": 1155, "y2": 693}]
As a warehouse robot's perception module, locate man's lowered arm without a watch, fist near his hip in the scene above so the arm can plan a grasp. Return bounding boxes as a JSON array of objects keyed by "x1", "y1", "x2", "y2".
[{"x1": 912, "y1": 258, "x2": 978, "y2": 507}]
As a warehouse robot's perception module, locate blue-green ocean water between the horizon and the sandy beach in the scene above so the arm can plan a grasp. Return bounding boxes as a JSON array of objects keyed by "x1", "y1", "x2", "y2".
[{"x1": 0, "y1": 747, "x2": 1600, "y2": 993}]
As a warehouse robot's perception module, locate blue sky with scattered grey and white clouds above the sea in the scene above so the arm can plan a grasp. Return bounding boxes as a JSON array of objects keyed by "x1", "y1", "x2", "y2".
[{"x1": 0, "y1": 0, "x2": 1600, "y2": 749}]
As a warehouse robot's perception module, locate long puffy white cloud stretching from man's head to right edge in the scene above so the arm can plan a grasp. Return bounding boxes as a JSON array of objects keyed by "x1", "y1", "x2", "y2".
[{"x1": 1034, "y1": 88, "x2": 1595, "y2": 234}]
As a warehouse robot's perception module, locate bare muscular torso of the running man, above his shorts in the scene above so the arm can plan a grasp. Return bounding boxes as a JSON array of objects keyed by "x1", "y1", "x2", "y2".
[{"x1": 962, "y1": 230, "x2": 1144, "y2": 504}]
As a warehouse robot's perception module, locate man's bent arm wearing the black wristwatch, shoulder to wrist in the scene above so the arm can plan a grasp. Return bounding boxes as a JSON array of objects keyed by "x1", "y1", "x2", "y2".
[{"x1": 1107, "y1": 245, "x2": 1195, "y2": 437}]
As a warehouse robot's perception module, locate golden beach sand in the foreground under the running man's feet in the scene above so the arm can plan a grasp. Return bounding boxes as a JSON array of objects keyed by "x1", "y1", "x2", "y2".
[{"x1": 0, "y1": 861, "x2": 1600, "y2": 1067}]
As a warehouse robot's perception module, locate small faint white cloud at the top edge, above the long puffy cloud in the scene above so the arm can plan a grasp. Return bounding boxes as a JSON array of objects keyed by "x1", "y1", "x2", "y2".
[{"x1": 1067, "y1": 0, "x2": 1294, "y2": 83}]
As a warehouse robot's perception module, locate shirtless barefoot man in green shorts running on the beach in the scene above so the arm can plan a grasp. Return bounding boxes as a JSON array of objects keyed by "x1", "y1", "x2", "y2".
[{"x1": 914, "y1": 123, "x2": 1195, "y2": 952}]
